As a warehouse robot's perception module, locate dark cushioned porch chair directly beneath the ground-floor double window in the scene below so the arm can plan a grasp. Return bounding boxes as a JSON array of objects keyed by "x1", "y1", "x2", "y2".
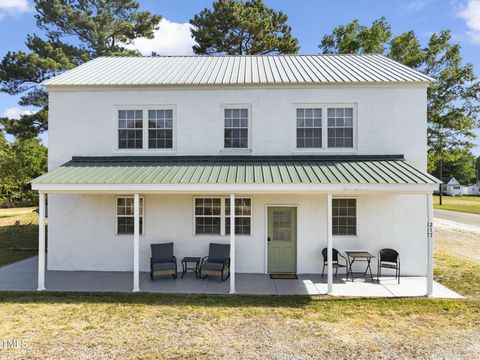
[{"x1": 200, "y1": 243, "x2": 230, "y2": 281}]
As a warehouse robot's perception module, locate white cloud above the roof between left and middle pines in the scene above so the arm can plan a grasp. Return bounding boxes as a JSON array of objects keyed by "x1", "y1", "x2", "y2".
[{"x1": 126, "y1": 18, "x2": 195, "y2": 55}]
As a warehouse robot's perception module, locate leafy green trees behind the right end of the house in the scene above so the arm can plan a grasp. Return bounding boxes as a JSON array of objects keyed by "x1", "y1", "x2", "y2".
[{"x1": 319, "y1": 18, "x2": 480, "y2": 177}]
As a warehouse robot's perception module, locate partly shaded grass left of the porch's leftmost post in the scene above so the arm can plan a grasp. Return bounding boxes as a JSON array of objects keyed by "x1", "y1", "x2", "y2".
[{"x1": 0, "y1": 208, "x2": 38, "y2": 266}]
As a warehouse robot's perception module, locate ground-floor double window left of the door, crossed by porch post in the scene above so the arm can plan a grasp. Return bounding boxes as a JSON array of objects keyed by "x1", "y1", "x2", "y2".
[{"x1": 194, "y1": 197, "x2": 252, "y2": 235}]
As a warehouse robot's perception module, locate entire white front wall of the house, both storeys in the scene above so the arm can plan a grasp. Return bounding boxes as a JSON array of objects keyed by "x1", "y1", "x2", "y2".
[{"x1": 48, "y1": 85, "x2": 426, "y2": 275}]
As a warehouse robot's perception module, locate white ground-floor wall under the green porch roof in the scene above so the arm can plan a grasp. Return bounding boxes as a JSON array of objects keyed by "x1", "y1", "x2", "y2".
[{"x1": 48, "y1": 195, "x2": 426, "y2": 276}]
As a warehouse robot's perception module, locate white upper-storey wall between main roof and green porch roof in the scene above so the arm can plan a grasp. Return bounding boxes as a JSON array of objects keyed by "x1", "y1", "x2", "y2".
[{"x1": 49, "y1": 85, "x2": 426, "y2": 170}]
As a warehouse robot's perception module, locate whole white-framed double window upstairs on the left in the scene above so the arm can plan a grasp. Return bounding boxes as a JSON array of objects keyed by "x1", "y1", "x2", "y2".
[{"x1": 117, "y1": 106, "x2": 175, "y2": 150}]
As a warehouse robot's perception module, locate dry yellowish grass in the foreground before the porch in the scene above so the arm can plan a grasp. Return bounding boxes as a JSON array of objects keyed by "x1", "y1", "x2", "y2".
[{"x1": 0, "y1": 207, "x2": 480, "y2": 359}]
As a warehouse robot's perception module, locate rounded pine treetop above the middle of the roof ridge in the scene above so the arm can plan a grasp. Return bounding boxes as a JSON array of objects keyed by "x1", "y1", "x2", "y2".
[{"x1": 190, "y1": 0, "x2": 298, "y2": 55}]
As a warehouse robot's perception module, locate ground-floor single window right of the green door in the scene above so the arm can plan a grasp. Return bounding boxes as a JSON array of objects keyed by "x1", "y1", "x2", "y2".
[{"x1": 332, "y1": 199, "x2": 357, "y2": 236}]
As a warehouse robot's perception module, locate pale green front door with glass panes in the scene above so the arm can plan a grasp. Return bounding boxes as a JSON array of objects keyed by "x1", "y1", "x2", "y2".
[{"x1": 267, "y1": 207, "x2": 297, "y2": 273}]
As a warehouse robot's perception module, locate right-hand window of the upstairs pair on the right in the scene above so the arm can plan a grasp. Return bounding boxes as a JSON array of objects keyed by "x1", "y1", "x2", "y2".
[{"x1": 327, "y1": 108, "x2": 353, "y2": 148}]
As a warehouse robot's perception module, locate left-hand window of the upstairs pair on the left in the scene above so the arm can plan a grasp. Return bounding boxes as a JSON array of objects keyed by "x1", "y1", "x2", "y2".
[{"x1": 118, "y1": 110, "x2": 143, "y2": 149}]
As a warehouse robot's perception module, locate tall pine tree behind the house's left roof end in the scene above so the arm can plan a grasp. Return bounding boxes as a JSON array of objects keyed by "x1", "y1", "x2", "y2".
[{"x1": 0, "y1": 0, "x2": 161, "y2": 139}]
